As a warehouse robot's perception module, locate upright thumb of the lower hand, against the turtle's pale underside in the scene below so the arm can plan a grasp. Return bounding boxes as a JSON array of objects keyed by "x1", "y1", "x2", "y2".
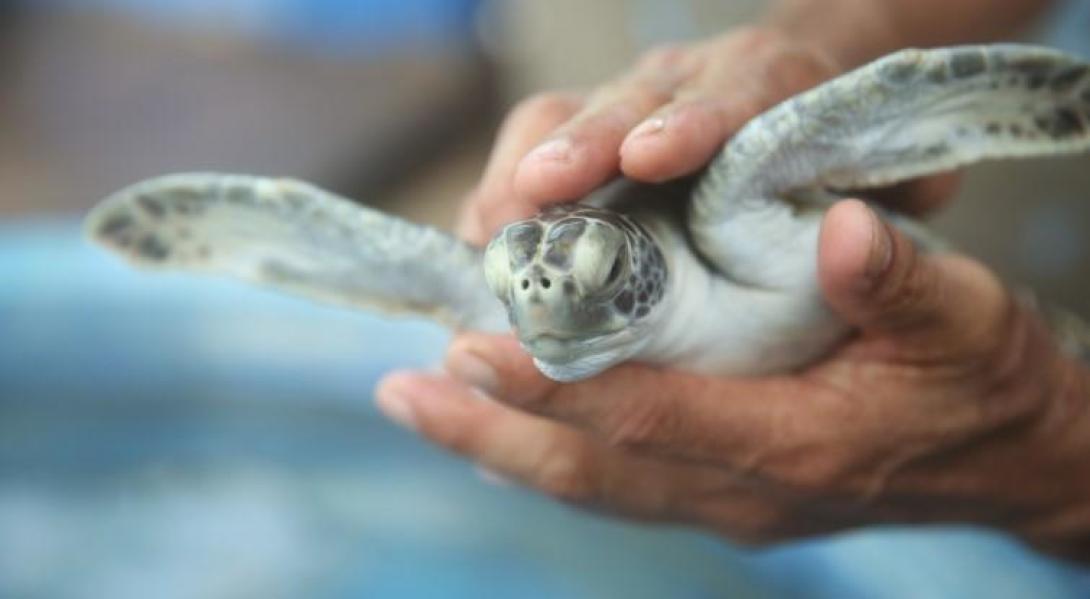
[{"x1": 819, "y1": 199, "x2": 1012, "y2": 350}]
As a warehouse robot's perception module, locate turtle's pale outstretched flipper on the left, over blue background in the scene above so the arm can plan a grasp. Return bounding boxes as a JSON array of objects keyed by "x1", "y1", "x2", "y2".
[{"x1": 85, "y1": 173, "x2": 509, "y2": 331}]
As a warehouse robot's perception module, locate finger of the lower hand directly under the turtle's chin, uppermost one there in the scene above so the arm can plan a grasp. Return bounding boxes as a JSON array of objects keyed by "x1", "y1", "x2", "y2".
[{"x1": 436, "y1": 333, "x2": 820, "y2": 469}]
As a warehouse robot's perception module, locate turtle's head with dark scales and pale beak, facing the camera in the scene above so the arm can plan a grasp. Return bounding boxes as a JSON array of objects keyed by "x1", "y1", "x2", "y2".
[{"x1": 484, "y1": 206, "x2": 666, "y2": 380}]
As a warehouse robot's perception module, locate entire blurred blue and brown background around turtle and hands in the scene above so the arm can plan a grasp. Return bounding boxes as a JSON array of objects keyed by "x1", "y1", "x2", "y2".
[{"x1": 0, "y1": 0, "x2": 1090, "y2": 598}]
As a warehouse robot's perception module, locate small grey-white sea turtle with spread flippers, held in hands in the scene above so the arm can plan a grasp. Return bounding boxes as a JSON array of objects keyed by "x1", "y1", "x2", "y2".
[{"x1": 87, "y1": 45, "x2": 1090, "y2": 381}]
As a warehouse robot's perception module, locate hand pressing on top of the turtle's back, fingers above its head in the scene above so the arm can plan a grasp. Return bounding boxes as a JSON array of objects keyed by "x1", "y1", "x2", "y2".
[{"x1": 459, "y1": 27, "x2": 956, "y2": 245}]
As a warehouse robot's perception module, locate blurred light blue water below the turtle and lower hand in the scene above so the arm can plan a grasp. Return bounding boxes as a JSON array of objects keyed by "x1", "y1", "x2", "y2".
[{"x1": 0, "y1": 222, "x2": 1090, "y2": 598}]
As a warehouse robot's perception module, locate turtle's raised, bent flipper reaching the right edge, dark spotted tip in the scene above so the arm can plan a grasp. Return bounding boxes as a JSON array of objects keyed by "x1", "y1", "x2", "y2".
[{"x1": 690, "y1": 44, "x2": 1090, "y2": 288}]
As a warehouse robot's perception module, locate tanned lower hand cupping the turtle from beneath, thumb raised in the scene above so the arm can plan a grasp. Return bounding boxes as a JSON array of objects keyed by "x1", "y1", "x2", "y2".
[{"x1": 378, "y1": 201, "x2": 1090, "y2": 559}]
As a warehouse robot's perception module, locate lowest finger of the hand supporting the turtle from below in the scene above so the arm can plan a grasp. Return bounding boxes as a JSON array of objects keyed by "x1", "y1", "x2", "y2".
[{"x1": 377, "y1": 374, "x2": 834, "y2": 542}]
